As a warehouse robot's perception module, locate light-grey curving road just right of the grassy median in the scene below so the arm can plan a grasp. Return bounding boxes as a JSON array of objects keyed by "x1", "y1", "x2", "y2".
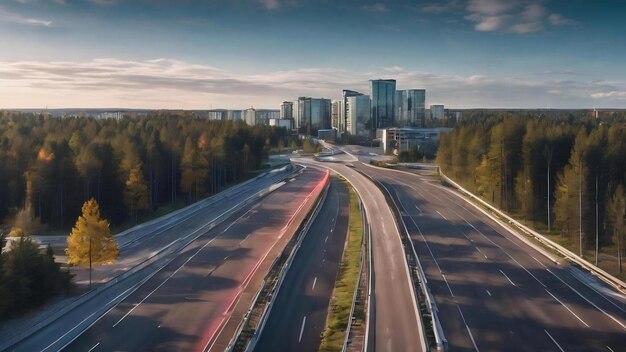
[{"x1": 296, "y1": 159, "x2": 425, "y2": 352}]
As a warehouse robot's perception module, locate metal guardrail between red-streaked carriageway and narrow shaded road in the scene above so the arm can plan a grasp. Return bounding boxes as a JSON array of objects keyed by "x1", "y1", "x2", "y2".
[{"x1": 241, "y1": 172, "x2": 330, "y2": 352}]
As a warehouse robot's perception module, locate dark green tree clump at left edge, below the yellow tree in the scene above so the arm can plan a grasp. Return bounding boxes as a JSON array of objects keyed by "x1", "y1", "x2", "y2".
[{"x1": 0, "y1": 234, "x2": 71, "y2": 321}]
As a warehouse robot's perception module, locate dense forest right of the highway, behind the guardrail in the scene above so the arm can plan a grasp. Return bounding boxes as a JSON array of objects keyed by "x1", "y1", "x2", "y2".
[{"x1": 437, "y1": 112, "x2": 626, "y2": 270}]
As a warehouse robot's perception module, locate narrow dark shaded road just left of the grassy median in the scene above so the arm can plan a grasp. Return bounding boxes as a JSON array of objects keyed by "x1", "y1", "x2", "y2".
[{"x1": 255, "y1": 180, "x2": 350, "y2": 352}]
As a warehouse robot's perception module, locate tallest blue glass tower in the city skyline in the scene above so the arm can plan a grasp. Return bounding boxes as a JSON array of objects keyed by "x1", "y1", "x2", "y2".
[{"x1": 370, "y1": 79, "x2": 396, "y2": 138}]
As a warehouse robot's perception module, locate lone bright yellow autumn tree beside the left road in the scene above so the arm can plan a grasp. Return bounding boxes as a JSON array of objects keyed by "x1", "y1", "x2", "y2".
[{"x1": 65, "y1": 198, "x2": 119, "y2": 285}]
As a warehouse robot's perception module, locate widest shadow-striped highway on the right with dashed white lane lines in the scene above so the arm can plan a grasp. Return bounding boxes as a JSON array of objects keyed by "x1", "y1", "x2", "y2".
[{"x1": 355, "y1": 163, "x2": 626, "y2": 351}]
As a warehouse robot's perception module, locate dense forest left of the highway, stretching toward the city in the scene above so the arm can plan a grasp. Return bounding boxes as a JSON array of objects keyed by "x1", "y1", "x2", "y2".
[{"x1": 0, "y1": 111, "x2": 287, "y2": 234}]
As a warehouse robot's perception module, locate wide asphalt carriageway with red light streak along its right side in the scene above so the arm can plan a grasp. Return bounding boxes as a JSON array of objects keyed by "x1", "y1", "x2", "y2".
[{"x1": 55, "y1": 170, "x2": 323, "y2": 351}]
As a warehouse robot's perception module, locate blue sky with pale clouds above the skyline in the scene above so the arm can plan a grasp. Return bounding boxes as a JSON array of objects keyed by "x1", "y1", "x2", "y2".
[{"x1": 0, "y1": 0, "x2": 626, "y2": 109}]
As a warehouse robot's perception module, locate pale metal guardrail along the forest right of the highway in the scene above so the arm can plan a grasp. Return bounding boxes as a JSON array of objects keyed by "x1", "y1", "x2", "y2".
[{"x1": 439, "y1": 169, "x2": 626, "y2": 293}]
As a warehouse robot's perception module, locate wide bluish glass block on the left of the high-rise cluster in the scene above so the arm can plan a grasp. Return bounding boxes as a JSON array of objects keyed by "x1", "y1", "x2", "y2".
[{"x1": 293, "y1": 97, "x2": 331, "y2": 133}]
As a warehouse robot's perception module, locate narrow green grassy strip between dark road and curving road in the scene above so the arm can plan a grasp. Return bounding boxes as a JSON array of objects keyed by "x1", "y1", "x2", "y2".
[{"x1": 319, "y1": 181, "x2": 363, "y2": 351}]
